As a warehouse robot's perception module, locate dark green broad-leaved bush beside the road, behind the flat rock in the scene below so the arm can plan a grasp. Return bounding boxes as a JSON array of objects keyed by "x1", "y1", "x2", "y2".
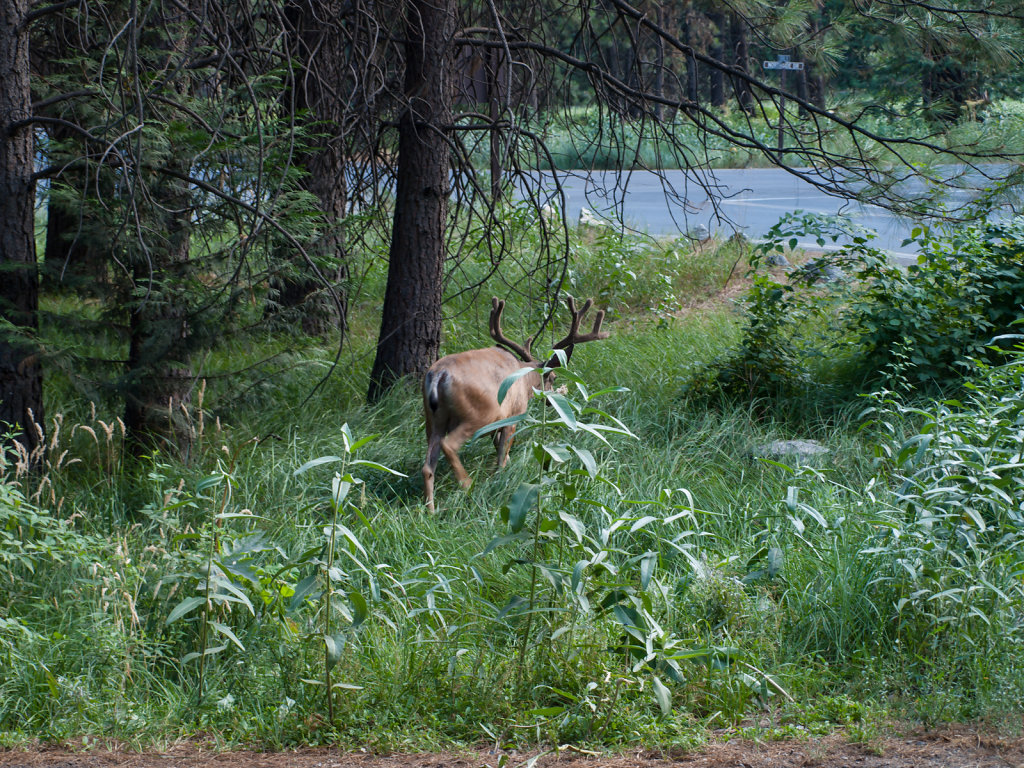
[{"x1": 697, "y1": 212, "x2": 1024, "y2": 399}]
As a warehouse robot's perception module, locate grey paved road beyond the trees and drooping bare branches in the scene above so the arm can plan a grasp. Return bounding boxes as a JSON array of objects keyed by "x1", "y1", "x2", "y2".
[{"x1": 528, "y1": 168, "x2": 983, "y2": 262}]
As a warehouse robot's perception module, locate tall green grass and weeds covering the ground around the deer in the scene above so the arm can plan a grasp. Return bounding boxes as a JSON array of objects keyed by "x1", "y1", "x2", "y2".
[{"x1": 6, "y1": 219, "x2": 1024, "y2": 750}]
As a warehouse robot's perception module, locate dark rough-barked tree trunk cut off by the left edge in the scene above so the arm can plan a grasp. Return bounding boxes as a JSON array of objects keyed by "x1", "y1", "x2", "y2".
[{"x1": 0, "y1": 0, "x2": 44, "y2": 463}]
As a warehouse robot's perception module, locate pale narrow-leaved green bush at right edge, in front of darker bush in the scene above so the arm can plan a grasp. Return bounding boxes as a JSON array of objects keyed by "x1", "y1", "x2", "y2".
[{"x1": 862, "y1": 347, "x2": 1024, "y2": 717}]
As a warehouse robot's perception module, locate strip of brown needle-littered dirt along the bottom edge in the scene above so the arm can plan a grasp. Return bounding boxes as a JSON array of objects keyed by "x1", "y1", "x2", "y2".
[{"x1": 0, "y1": 728, "x2": 1024, "y2": 768}]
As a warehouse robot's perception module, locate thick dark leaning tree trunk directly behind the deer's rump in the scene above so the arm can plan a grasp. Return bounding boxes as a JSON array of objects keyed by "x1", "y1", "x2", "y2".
[{"x1": 367, "y1": 0, "x2": 455, "y2": 402}]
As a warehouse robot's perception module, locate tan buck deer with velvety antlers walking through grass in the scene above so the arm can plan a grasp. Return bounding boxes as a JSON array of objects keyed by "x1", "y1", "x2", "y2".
[{"x1": 423, "y1": 297, "x2": 608, "y2": 512}]
